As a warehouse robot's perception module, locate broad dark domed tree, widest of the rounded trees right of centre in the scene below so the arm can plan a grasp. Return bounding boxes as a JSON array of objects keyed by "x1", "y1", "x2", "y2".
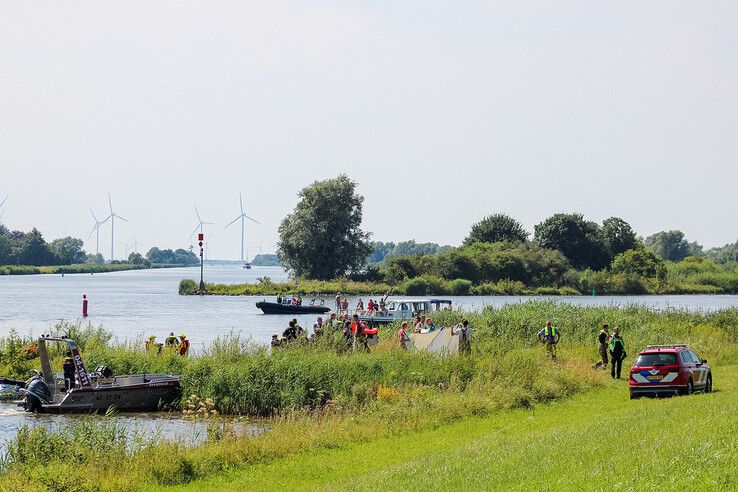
[{"x1": 535, "y1": 214, "x2": 610, "y2": 270}]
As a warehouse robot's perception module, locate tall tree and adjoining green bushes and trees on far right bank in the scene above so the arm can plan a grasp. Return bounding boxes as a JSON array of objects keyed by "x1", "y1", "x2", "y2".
[{"x1": 278, "y1": 175, "x2": 738, "y2": 295}]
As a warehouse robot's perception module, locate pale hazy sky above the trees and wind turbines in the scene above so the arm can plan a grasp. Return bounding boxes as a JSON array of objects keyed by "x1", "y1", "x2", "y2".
[{"x1": 0, "y1": 0, "x2": 738, "y2": 259}]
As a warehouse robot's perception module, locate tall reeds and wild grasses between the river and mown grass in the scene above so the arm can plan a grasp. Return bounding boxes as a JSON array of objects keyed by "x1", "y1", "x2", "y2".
[{"x1": 0, "y1": 301, "x2": 738, "y2": 490}]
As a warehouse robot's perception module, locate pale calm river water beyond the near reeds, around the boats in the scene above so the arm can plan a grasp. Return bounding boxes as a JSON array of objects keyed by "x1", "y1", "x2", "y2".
[{"x1": 0, "y1": 265, "x2": 738, "y2": 351}]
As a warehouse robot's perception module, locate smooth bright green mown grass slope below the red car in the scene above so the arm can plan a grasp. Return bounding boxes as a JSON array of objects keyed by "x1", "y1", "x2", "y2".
[{"x1": 168, "y1": 366, "x2": 738, "y2": 491}]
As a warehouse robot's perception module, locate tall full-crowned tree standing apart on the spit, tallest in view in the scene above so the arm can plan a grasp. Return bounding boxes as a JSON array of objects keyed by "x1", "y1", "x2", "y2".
[{"x1": 277, "y1": 174, "x2": 372, "y2": 279}]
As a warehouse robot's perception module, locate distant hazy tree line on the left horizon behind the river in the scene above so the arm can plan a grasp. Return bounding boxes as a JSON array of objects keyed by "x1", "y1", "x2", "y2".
[{"x1": 0, "y1": 224, "x2": 200, "y2": 267}]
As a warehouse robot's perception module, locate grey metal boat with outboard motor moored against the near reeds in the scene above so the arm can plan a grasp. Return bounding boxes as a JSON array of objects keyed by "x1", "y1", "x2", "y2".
[{"x1": 18, "y1": 337, "x2": 182, "y2": 413}]
